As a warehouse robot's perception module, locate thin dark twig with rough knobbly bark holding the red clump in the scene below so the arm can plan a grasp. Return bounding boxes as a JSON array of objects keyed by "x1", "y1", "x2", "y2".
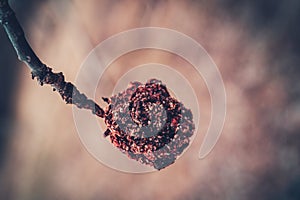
[{"x1": 0, "y1": 0, "x2": 104, "y2": 117}]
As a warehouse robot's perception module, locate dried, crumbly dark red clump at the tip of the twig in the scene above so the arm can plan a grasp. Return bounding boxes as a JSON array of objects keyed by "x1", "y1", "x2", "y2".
[{"x1": 103, "y1": 79, "x2": 195, "y2": 170}]
